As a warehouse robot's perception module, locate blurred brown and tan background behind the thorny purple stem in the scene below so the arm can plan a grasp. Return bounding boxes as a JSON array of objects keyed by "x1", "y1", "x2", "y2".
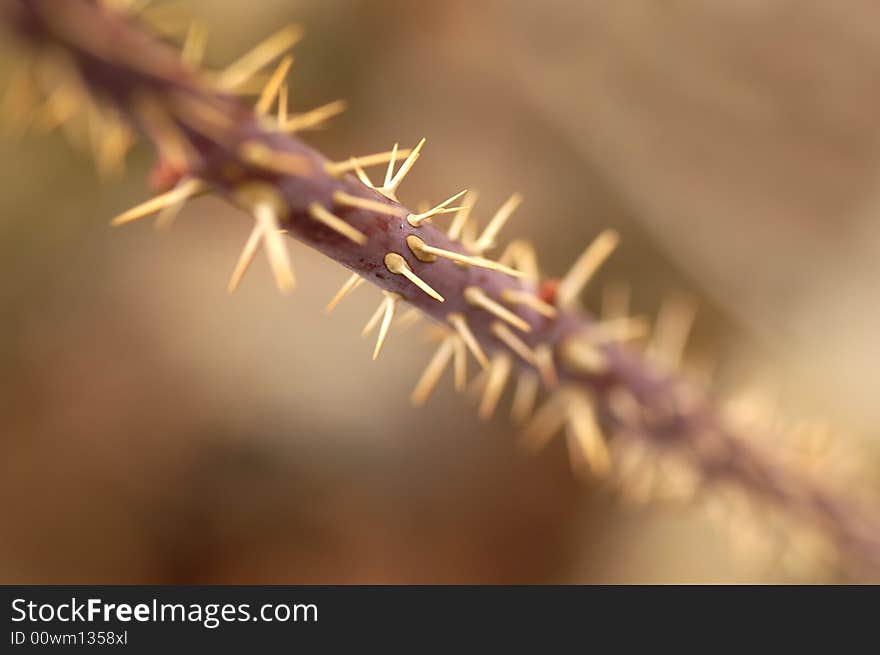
[{"x1": 0, "y1": 0, "x2": 880, "y2": 583}]
